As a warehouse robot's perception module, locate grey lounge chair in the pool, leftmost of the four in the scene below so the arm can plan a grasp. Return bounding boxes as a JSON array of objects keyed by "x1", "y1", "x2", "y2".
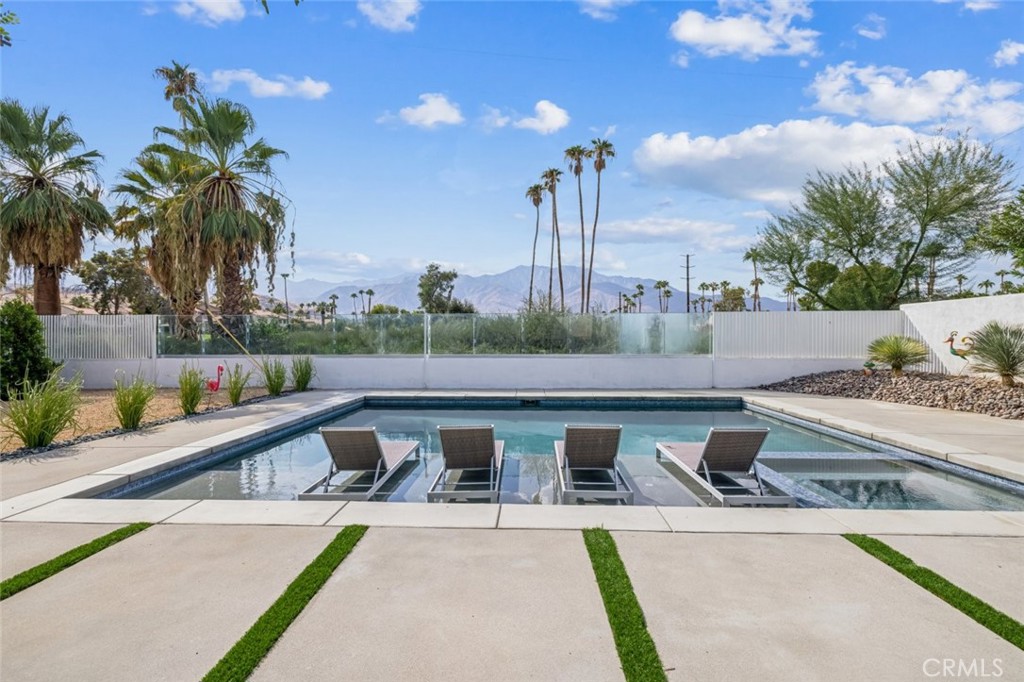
[{"x1": 299, "y1": 427, "x2": 420, "y2": 500}]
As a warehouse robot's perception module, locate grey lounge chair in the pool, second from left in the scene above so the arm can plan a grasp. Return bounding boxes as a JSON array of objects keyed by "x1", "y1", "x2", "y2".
[{"x1": 427, "y1": 426, "x2": 505, "y2": 502}]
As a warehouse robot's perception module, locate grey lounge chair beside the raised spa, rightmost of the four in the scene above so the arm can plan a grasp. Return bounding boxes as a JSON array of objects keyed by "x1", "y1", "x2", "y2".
[{"x1": 654, "y1": 427, "x2": 796, "y2": 507}]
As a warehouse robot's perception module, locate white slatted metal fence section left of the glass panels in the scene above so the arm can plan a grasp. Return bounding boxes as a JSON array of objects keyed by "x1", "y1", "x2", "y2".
[{"x1": 41, "y1": 315, "x2": 157, "y2": 360}]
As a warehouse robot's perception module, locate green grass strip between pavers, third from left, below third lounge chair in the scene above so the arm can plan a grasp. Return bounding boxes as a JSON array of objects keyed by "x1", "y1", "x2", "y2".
[{"x1": 583, "y1": 528, "x2": 667, "y2": 682}]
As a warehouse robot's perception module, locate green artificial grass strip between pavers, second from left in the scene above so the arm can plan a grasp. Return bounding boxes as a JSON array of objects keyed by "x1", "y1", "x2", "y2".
[{"x1": 203, "y1": 525, "x2": 367, "y2": 682}]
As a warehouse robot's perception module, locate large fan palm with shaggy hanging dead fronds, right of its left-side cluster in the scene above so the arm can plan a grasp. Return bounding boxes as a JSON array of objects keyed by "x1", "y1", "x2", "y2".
[{"x1": 148, "y1": 97, "x2": 288, "y2": 315}]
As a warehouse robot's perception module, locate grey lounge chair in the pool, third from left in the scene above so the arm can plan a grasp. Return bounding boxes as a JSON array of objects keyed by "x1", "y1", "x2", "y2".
[{"x1": 555, "y1": 424, "x2": 634, "y2": 505}]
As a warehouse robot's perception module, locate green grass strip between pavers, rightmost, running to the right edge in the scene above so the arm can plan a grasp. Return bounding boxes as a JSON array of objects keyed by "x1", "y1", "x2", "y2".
[{"x1": 843, "y1": 534, "x2": 1024, "y2": 649}]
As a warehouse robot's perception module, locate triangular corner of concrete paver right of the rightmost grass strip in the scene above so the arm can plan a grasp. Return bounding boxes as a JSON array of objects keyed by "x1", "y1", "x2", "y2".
[{"x1": 878, "y1": 536, "x2": 1024, "y2": 622}]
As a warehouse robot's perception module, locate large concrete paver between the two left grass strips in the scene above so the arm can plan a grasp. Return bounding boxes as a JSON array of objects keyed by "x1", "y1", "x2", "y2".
[{"x1": 0, "y1": 525, "x2": 333, "y2": 682}]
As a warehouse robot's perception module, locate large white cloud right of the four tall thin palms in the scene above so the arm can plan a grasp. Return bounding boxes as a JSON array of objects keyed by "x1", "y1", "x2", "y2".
[{"x1": 633, "y1": 117, "x2": 919, "y2": 206}]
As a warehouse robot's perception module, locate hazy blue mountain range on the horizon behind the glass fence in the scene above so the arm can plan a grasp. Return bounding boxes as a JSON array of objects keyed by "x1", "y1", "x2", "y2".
[{"x1": 264, "y1": 265, "x2": 785, "y2": 312}]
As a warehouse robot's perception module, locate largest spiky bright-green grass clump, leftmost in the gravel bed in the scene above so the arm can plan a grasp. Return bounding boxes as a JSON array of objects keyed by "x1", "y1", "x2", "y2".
[{"x1": 0, "y1": 370, "x2": 82, "y2": 447}]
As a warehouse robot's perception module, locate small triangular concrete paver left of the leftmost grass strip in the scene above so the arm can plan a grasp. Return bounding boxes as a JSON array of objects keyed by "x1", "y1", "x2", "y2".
[{"x1": 0, "y1": 521, "x2": 122, "y2": 580}]
